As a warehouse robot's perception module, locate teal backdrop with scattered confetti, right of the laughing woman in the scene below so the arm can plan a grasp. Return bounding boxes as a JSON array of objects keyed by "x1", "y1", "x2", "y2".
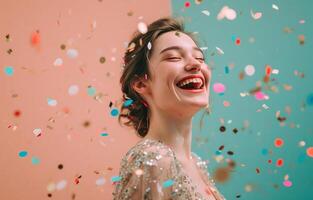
[{"x1": 171, "y1": 0, "x2": 313, "y2": 200}]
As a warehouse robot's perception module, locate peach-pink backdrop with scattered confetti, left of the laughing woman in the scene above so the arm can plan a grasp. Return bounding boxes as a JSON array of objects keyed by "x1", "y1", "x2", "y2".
[{"x1": 0, "y1": 0, "x2": 171, "y2": 200}]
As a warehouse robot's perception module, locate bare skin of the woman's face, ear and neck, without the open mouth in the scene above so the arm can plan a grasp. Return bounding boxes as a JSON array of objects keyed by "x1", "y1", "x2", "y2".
[{"x1": 133, "y1": 31, "x2": 211, "y2": 162}]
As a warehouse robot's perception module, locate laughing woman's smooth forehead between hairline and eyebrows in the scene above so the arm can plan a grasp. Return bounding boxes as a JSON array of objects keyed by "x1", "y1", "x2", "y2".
[{"x1": 153, "y1": 31, "x2": 197, "y2": 54}]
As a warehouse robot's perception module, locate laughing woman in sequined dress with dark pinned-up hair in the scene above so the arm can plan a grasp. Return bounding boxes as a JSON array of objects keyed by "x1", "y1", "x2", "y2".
[{"x1": 113, "y1": 17, "x2": 225, "y2": 200}]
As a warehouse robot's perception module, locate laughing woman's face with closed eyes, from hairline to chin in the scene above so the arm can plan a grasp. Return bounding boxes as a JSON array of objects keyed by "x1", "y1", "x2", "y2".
[{"x1": 140, "y1": 31, "x2": 211, "y2": 117}]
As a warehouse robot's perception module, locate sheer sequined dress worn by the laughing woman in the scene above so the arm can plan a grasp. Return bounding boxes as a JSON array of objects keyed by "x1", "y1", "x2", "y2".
[{"x1": 112, "y1": 138, "x2": 226, "y2": 200}]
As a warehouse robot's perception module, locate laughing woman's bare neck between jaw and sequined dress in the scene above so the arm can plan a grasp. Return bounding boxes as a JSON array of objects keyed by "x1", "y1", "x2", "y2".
[{"x1": 145, "y1": 108, "x2": 192, "y2": 160}]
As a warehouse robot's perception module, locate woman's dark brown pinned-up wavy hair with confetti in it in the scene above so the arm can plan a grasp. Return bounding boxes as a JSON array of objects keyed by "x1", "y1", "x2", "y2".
[{"x1": 118, "y1": 17, "x2": 202, "y2": 138}]
